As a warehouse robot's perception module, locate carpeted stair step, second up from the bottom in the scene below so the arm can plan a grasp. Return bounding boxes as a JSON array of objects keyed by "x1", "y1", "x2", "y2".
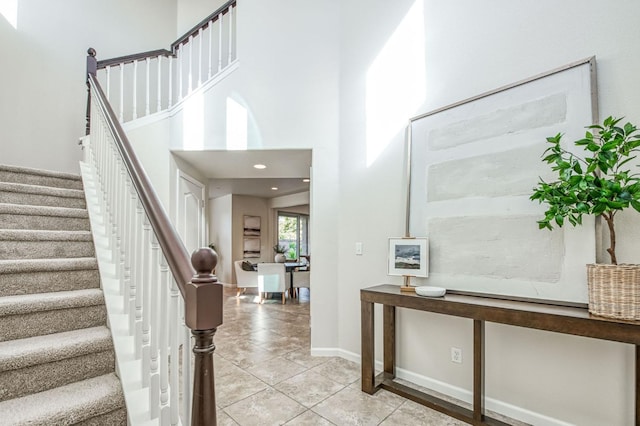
[{"x1": 0, "y1": 326, "x2": 115, "y2": 401}]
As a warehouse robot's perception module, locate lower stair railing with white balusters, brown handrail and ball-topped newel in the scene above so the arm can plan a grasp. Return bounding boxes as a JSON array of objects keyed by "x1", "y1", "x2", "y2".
[{"x1": 85, "y1": 74, "x2": 222, "y2": 426}]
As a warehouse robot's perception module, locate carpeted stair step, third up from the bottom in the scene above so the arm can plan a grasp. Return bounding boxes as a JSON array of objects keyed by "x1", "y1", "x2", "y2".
[{"x1": 0, "y1": 289, "x2": 107, "y2": 342}]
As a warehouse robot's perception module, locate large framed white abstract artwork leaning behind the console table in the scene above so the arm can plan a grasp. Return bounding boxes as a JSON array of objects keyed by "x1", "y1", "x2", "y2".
[{"x1": 406, "y1": 58, "x2": 598, "y2": 303}]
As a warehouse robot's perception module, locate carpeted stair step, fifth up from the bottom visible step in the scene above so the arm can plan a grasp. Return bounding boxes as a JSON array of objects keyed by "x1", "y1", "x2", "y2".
[{"x1": 0, "y1": 229, "x2": 95, "y2": 259}]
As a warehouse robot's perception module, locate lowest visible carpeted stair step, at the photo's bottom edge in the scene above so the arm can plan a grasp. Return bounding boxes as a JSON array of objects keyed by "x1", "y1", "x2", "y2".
[{"x1": 0, "y1": 373, "x2": 127, "y2": 425}]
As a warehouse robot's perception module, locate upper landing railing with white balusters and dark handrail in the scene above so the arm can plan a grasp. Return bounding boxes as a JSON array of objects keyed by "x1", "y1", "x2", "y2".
[{"x1": 97, "y1": 0, "x2": 237, "y2": 123}]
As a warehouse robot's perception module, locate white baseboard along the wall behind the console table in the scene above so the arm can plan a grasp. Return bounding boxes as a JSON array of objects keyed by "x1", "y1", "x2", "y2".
[{"x1": 311, "y1": 348, "x2": 572, "y2": 426}]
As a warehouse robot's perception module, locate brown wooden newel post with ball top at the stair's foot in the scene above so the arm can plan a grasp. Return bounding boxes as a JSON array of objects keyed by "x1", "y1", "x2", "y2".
[{"x1": 185, "y1": 248, "x2": 222, "y2": 426}]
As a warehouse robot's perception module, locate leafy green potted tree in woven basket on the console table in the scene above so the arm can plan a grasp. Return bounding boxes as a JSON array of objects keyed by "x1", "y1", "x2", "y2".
[{"x1": 531, "y1": 117, "x2": 640, "y2": 319}]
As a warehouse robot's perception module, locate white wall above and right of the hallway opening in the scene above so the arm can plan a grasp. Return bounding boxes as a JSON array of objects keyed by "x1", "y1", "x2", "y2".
[{"x1": 171, "y1": 0, "x2": 339, "y2": 353}]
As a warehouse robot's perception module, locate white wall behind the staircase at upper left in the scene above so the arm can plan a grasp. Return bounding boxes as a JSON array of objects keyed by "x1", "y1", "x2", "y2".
[{"x1": 0, "y1": 0, "x2": 176, "y2": 173}]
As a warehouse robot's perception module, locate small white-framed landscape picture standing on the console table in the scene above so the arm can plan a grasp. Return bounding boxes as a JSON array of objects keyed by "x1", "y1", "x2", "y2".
[{"x1": 388, "y1": 238, "x2": 429, "y2": 277}]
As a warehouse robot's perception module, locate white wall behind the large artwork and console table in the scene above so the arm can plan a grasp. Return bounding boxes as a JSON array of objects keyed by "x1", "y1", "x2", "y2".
[{"x1": 336, "y1": 0, "x2": 640, "y2": 425}]
